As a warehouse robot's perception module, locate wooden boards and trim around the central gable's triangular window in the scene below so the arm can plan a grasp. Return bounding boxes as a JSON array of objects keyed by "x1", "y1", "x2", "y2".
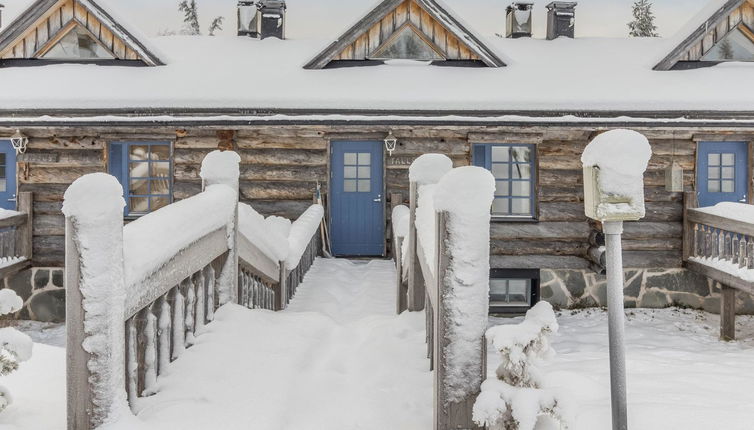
[{"x1": 304, "y1": 0, "x2": 505, "y2": 69}]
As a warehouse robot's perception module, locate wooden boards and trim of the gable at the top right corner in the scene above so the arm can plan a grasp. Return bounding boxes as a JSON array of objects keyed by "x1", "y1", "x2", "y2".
[{"x1": 654, "y1": 0, "x2": 754, "y2": 71}]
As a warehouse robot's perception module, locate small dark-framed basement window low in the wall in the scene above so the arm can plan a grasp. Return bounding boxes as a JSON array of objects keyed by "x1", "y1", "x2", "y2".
[{"x1": 490, "y1": 269, "x2": 539, "y2": 314}]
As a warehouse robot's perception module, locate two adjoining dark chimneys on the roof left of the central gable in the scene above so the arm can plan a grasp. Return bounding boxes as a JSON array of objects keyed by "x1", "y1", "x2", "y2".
[{"x1": 238, "y1": 0, "x2": 286, "y2": 39}]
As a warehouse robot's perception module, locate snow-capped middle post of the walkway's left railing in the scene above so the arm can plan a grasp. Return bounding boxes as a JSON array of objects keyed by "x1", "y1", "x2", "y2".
[{"x1": 199, "y1": 151, "x2": 241, "y2": 306}]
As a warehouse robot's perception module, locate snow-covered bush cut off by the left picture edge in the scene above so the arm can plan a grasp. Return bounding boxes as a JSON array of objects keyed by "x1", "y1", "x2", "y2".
[{"x1": 0, "y1": 289, "x2": 34, "y2": 411}]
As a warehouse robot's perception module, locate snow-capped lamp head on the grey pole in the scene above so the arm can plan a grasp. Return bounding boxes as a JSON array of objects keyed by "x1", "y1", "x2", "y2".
[{"x1": 581, "y1": 130, "x2": 652, "y2": 222}]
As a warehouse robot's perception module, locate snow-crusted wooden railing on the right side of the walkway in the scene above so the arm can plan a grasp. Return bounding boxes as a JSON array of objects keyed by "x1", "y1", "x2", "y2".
[{"x1": 394, "y1": 155, "x2": 494, "y2": 430}]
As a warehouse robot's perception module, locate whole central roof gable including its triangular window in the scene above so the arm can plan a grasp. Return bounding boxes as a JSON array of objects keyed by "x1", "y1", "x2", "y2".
[{"x1": 305, "y1": 0, "x2": 505, "y2": 69}]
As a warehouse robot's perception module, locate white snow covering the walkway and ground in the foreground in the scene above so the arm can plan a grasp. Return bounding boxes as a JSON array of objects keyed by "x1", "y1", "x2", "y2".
[{"x1": 0, "y1": 260, "x2": 754, "y2": 430}]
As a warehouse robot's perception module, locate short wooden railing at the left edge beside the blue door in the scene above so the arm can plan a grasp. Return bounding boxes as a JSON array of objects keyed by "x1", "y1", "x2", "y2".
[{"x1": 0, "y1": 192, "x2": 33, "y2": 279}]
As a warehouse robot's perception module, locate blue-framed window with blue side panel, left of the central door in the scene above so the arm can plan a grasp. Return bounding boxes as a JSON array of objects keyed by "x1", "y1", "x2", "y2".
[{"x1": 109, "y1": 142, "x2": 173, "y2": 216}]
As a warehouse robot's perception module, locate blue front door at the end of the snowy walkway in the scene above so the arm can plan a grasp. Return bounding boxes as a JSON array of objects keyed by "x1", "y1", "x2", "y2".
[{"x1": 330, "y1": 142, "x2": 385, "y2": 256}]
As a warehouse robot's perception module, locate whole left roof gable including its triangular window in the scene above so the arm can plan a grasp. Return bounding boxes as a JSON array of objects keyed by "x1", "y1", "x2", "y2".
[{"x1": 0, "y1": 0, "x2": 163, "y2": 66}]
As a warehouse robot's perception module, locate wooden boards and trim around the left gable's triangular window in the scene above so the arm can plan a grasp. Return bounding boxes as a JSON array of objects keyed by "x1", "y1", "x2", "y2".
[{"x1": 0, "y1": 0, "x2": 164, "y2": 66}]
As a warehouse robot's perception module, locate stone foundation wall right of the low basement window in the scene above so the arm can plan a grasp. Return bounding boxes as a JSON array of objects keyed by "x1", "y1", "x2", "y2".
[{"x1": 540, "y1": 269, "x2": 754, "y2": 315}]
